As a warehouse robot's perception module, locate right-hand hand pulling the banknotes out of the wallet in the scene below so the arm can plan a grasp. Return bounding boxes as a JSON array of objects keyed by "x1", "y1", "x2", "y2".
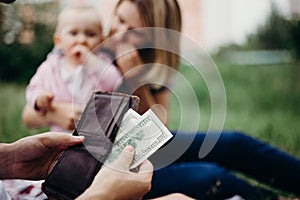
[{"x1": 77, "y1": 146, "x2": 153, "y2": 200}]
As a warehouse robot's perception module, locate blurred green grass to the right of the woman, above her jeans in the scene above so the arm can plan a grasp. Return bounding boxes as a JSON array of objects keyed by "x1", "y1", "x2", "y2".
[{"x1": 169, "y1": 62, "x2": 300, "y2": 158}]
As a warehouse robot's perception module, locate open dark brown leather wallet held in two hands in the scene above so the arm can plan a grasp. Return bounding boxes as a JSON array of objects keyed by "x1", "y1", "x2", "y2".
[{"x1": 42, "y1": 91, "x2": 139, "y2": 200}]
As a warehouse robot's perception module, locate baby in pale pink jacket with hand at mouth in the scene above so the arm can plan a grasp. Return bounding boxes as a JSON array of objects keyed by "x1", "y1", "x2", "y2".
[{"x1": 26, "y1": 5, "x2": 122, "y2": 131}]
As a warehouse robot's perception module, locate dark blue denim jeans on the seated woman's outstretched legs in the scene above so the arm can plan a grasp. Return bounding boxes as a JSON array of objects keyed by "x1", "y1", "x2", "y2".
[{"x1": 145, "y1": 131, "x2": 300, "y2": 199}]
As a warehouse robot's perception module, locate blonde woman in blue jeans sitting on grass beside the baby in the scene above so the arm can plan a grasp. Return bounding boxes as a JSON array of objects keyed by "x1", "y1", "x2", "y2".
[{"x1": 23, "y1": 0, "x2": 300, "y2": 199}]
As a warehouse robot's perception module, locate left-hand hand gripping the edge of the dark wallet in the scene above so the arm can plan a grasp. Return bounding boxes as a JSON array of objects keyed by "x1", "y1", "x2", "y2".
[{"x1": 7, "y1": 132, "x2": 84, "y2": 180}]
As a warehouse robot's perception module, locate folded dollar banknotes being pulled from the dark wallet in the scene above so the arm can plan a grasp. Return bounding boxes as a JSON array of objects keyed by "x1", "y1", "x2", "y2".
[{"x1": 106, "y1": 109, "x2": 173, "y2": 169}]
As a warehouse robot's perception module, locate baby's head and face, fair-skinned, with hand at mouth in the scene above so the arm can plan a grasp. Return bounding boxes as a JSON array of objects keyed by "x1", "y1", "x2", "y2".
[{"x1": 56, "y1": 10, "x2": 102, "y2": 62}]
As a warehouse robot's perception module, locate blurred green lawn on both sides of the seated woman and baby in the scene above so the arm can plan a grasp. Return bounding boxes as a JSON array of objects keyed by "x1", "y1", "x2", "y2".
[{"x1": 0, "y1": 62, "x2": 300, "y2": 158}]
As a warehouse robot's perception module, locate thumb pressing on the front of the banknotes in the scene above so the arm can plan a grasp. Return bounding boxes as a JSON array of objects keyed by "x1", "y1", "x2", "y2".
[{"x1": 112, "y1": 146, "x2": 134, "y2": 171}]
